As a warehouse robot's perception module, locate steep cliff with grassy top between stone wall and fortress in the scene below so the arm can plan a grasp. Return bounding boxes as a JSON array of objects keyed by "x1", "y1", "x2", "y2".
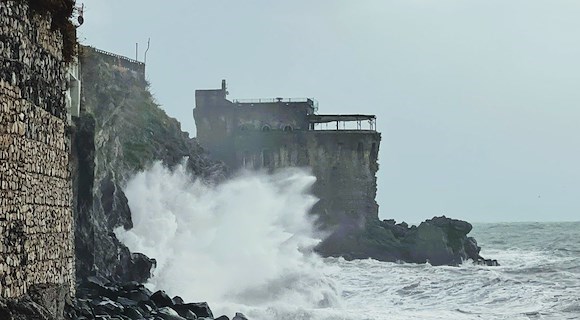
[{"x1": 73, "y1": 47, "x2": 224, "y2": 281}]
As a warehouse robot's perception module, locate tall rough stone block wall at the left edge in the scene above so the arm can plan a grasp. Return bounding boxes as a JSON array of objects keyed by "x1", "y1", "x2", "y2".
[{"x1": 0, "y1": 1, "x2": 74, "y2": 298}]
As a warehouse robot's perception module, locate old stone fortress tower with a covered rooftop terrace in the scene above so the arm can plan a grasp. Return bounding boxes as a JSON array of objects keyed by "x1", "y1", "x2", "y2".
[{"x1": 194, "y1": 81, "x2": 381, "y2": 227}]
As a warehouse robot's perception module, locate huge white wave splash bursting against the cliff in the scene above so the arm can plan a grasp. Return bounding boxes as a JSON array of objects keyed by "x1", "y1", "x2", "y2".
[{"x1": 115, "y1": 163, "x2": 340, "y2": 313}]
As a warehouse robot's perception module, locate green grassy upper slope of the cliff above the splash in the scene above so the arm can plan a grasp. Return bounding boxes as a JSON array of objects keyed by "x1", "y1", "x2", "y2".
[{"x1": 81, "y1": 48, "x2": 199, "y2": 178}]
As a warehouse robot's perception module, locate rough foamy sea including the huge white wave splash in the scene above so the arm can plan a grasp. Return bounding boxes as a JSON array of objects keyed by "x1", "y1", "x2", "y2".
[{"x1": 116, "y1": 164, "x2": 580, "y2": 320}]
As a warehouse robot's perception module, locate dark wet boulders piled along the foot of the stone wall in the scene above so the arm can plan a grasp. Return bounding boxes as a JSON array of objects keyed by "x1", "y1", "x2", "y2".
[{"x1": 0, "y1": 277, "x2": 248, "y2": 320}]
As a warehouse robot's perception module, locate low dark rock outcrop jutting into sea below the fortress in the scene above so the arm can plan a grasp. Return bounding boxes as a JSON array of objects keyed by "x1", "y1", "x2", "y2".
[{"x1": 317, "y1": 216, "x2": 498, "y2": 265}]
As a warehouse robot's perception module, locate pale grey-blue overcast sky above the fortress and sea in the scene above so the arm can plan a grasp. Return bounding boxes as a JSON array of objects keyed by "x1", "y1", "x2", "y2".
[{"x1": 77, "y1": 0, "x2": 580, "y2": 222}]
